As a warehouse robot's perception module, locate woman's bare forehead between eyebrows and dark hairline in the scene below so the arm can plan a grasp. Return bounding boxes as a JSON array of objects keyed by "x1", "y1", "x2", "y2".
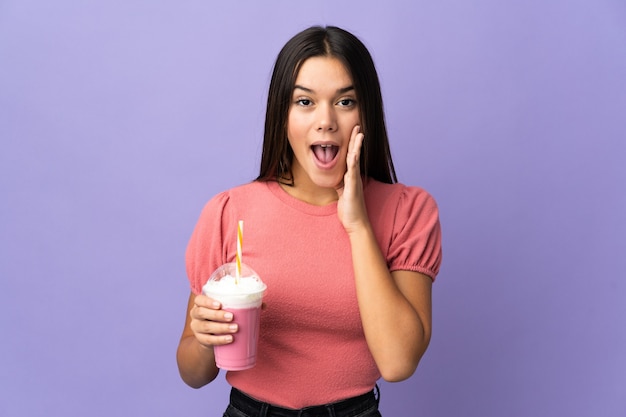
[{"x1": 296, "y1": 57, "x2": 352, "y2": 89}]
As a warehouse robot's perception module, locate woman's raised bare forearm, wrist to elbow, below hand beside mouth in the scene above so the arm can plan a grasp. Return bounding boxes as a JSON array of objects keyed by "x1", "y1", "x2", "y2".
[{"x1": 350, "y1": 224, "x2": 430, "y2": 381}]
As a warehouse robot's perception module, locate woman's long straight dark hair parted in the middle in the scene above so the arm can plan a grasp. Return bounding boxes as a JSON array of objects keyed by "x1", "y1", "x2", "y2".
[{"x1": 256, "y1": 26, "x2": 397, "y2": 184}]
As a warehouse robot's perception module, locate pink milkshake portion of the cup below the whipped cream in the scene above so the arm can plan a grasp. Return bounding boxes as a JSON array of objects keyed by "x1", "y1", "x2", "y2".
[{"x1": 213, "y1": 307, "x2": 261, "y2": 371}]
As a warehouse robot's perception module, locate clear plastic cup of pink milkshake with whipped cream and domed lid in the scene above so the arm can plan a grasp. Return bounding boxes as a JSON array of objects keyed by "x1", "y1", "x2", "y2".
[{"x1": 202, "y1": 263, "x2": 267, "y2": 371}]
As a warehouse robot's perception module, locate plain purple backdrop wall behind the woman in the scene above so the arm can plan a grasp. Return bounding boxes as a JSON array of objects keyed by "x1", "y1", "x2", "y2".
[{"x1": 0, "y1": 0, "x2": 626, "y2": 417}]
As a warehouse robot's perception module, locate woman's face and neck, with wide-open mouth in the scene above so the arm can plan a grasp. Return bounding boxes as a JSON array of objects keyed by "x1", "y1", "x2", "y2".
[{"x1": 287, "y1": 57, "x2": 360, "y2": 200}]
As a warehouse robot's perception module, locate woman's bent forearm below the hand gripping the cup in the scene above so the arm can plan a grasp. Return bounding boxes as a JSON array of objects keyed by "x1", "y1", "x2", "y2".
[{"x1": 176, "y1": 334, "x2": 219, "y2": 388}]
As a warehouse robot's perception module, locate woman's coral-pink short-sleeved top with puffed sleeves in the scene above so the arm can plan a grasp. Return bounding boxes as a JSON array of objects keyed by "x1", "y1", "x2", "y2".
[{"x1": 186, "y1": 180, "x2": 441, "y2": 408}]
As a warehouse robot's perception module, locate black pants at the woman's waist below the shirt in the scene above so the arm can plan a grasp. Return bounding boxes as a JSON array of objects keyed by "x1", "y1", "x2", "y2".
[{"x1": 224, "y1": 386, "x2": 381, "y2": 417}]
